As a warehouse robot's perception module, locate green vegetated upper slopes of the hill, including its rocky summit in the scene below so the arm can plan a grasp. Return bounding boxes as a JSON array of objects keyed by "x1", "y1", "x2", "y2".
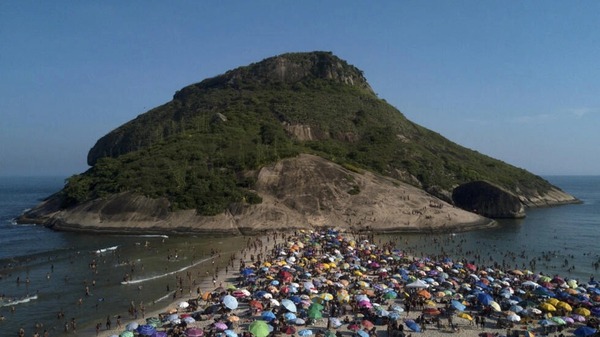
[{"x1": 62, "y1": 52, "x2": 551, "y2": 215}]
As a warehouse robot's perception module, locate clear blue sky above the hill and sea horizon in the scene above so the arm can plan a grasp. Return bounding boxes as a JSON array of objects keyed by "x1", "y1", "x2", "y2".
[{"x1": 0, "y1": 0, "x2": 600, "y2": 176}]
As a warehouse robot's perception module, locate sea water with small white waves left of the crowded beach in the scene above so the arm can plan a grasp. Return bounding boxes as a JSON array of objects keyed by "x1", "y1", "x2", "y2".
[{"x1": 0, "y1": 177, "x2": 247, "y2": 336}]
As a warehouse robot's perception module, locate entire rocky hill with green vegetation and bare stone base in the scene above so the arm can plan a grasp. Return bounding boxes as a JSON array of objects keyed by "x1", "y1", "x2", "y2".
[{"x1": 21, "y1": 52, "x2": 577, "y2": 233}]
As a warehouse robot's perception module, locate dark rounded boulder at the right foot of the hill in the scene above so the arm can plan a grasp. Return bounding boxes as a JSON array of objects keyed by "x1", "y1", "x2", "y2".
[{"x1": 452, "y1": 181, "x2": 525, "y2": 218}]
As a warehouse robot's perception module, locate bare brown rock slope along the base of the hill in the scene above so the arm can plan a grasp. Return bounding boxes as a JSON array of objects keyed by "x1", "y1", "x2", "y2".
[{"x1": 19, "y1": 154, "x2": 493, "y2": 234}]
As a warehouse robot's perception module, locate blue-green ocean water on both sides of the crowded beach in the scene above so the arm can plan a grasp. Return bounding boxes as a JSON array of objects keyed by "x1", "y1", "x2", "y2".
[{"x1": 0, "y1": 176, "x2": 600, "y2": 336}]
